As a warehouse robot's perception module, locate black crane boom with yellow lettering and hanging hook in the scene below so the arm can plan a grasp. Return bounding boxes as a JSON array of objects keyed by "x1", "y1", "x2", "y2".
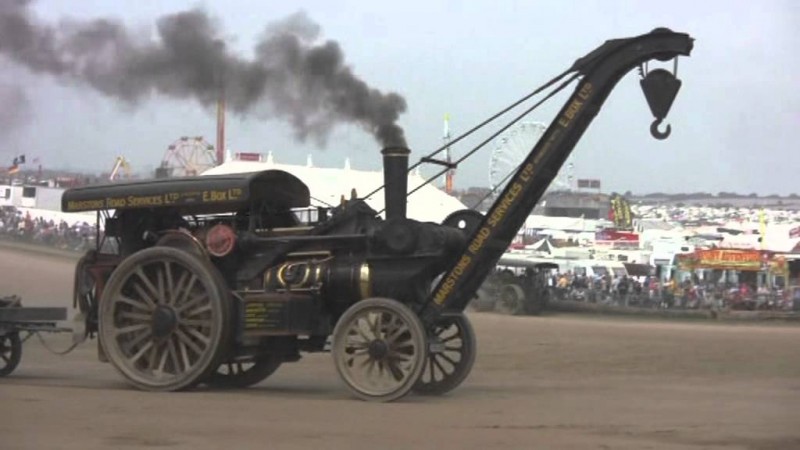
[{"x1": 422, "y1": 28, "x2": 694, "y2": 320}]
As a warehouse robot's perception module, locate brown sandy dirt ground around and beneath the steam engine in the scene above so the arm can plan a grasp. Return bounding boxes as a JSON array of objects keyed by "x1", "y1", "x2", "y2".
[{"x1": 0, "y1": 250, "x2": 800, "y2": 450}]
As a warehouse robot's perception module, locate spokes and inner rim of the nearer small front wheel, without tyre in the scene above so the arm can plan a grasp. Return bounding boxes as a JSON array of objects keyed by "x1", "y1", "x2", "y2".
[{"x1": 336, "y1": 308, "x2": 425, "y2": 397}]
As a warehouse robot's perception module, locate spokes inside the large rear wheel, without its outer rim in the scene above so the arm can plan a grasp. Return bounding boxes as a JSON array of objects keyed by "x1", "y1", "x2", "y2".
[{"x1": 103, "y1": 259, "x2": 221, "y2": 386}]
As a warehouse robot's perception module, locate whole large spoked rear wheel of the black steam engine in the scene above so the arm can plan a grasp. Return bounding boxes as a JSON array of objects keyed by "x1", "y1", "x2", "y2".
[{"x1": 99, "y1": 247, "x2": 231, "y2": 391}]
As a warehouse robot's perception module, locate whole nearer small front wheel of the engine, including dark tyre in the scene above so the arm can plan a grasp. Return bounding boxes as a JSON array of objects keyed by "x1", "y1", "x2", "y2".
[{"x1": 332, "y1": 298, "x2": 427, "y2": 402}]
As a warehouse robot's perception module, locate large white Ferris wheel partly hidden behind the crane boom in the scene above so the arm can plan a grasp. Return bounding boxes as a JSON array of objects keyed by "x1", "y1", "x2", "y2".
[{"x1": 489, "y1": 122, "x2": 575, "y2": 193}]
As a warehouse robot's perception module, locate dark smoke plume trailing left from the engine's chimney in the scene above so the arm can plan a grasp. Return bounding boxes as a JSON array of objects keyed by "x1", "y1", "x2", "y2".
[{"x1": 0, "y1": 0, "x2": 406, "y2": 146}]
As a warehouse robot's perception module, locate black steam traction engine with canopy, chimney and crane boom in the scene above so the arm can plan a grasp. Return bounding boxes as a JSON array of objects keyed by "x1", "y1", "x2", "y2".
[{"x1": 4, "y1": 29, "x2": 692, "y2": 401}]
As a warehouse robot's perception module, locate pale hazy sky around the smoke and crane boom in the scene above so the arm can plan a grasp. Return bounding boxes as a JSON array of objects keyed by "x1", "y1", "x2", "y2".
[{"x1": 0, "y1": 0, "x2": 800, "y2": 194}]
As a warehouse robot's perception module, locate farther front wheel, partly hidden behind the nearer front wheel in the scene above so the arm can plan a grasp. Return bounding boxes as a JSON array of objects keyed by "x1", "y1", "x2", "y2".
[{"x1": 414, "y1": 313, "x2": 477, "y2": 395}]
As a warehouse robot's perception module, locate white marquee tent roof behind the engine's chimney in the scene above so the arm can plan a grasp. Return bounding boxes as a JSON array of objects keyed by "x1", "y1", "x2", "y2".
[{"x1": 203, "y1": 158, "x2": 466, "y2": 223}]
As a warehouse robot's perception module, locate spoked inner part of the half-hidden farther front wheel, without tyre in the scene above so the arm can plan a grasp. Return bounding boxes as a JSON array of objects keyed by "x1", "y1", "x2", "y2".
[{"x1": 419, "y1": 320, "x2": 462, "y2": 384}]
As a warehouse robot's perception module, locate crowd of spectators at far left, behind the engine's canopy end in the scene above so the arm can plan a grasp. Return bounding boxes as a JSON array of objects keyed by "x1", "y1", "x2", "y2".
[{"x1": 0, "y1": 207, "x2": 97, "y2": 252}]
